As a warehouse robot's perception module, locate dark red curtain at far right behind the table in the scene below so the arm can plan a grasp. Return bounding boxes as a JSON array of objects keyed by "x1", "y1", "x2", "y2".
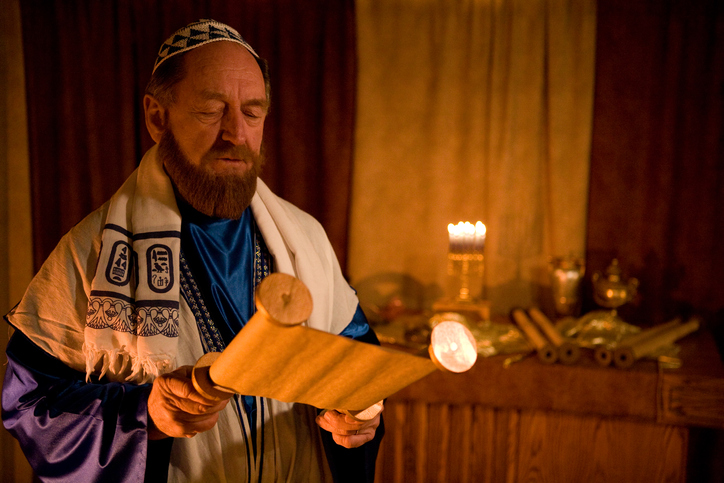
[{"x1": 587, "y1": 0, "x2": 724, "y2": 331}]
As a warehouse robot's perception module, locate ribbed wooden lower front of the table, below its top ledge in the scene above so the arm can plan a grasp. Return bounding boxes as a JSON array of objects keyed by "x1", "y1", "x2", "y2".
[{"x1": 376, "y1": 400, "x2": 688, "y2": 483}]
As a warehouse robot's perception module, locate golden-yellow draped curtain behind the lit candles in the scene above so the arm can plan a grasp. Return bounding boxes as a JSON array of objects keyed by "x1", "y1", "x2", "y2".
[{"x1": 348, "y1": 0, "x2": 596, "y2": 313}]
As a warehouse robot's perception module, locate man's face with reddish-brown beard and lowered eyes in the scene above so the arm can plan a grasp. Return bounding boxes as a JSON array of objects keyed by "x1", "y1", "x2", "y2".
[{"x1": 159, "y1": 41, "x2": 268, "y2": 218}]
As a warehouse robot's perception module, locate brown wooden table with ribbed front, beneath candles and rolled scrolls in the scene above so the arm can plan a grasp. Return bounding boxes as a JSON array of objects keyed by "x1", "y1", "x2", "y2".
[{"x1": 377, "y1": 331, "x2": 724, "y2": 483}]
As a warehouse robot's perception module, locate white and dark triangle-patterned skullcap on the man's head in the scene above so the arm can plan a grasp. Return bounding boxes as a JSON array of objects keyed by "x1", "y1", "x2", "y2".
[{"x1": 153, "y1": 18, "x2": 259, "y2": 72}]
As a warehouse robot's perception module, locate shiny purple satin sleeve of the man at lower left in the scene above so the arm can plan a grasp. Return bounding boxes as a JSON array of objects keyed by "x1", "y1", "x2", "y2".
[{"x1": 2, "y1": 332, "x2": 163, "y2": 483}]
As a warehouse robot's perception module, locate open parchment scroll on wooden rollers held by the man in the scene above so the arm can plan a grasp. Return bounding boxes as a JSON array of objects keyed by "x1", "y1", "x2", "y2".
[{"x1": 192, "y1": 273, "x2": 477, "y2": 420}]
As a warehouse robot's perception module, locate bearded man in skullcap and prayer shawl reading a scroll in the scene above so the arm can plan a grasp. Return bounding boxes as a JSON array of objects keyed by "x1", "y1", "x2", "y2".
[{"x1": 3, "y1": 20, "x2": 383, "y2": 481}]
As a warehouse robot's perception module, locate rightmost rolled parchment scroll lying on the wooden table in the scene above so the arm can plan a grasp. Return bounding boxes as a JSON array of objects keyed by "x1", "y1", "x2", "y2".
[{"x1": 613, "y1": 318, "x2": 699, "y2": 369}]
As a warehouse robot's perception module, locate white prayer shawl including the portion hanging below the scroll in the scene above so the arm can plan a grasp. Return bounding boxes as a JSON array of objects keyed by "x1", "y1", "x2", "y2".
[{"x1": 7, "y1": 147, "x2": 358, "y2": 481}]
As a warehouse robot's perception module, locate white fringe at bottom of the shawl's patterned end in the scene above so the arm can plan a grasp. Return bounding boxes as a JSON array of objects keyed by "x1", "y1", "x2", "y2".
[{"x1": 83, "y1": 344, "x2": 173, "y2": 384}]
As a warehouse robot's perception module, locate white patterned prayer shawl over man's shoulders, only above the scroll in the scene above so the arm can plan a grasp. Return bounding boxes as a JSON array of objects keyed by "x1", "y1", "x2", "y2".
[{"x1": 8, "y1": 146, "x2": 357, "y2": 382}]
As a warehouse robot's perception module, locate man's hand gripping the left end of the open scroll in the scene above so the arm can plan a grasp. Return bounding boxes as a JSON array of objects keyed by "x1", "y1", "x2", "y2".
[{"x1": 148, "y1": 366, "x2": 232, "y2": 439}]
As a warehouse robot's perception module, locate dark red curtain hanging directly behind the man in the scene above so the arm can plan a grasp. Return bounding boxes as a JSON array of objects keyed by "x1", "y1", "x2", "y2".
[{"x1": 21, "y1": 0, "x2": 356, "y2": 269}]
